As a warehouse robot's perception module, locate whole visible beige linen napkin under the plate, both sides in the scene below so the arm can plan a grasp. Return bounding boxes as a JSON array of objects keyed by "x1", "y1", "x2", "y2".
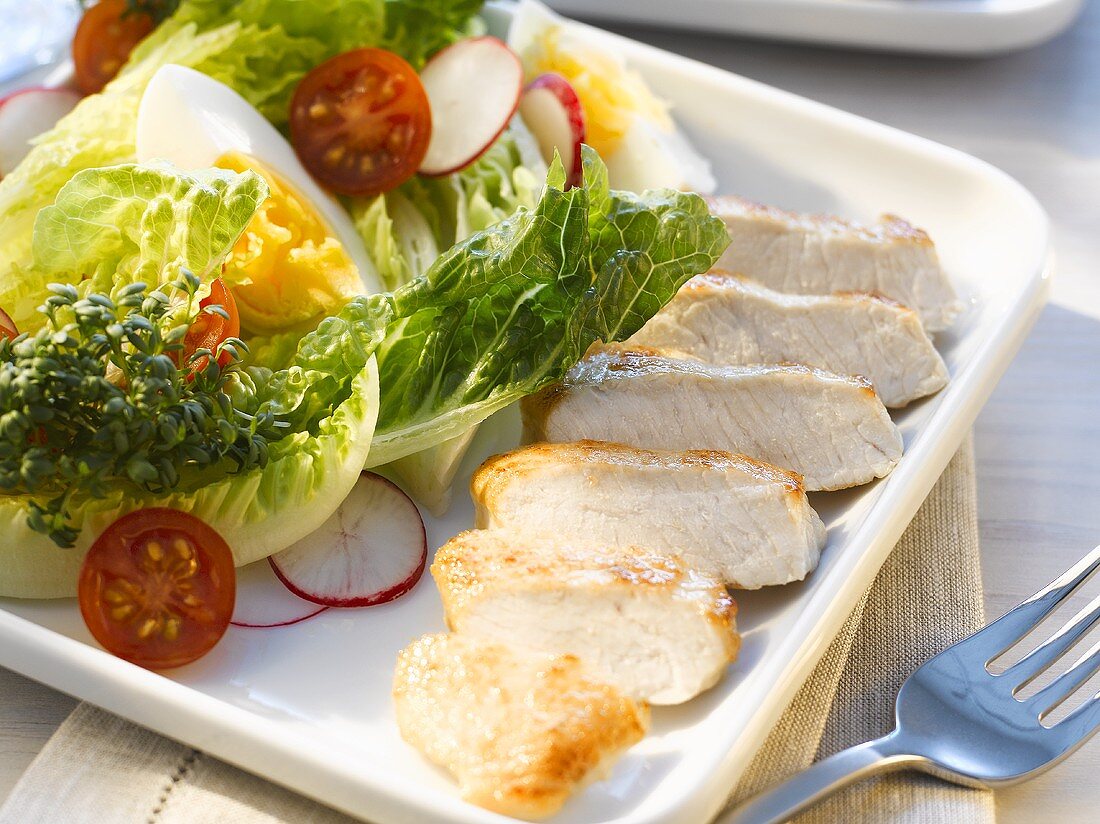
[{"x1": 0, "y1": 441, "x2": 993, "y2": 824}]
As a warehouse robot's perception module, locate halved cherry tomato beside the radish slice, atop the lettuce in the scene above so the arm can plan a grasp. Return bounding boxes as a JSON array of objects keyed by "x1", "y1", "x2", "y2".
[{"x1": 290, "y1": 48, "x2": 431, "y2": 196}]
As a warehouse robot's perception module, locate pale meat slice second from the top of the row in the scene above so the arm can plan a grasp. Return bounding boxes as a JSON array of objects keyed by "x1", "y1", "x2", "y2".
[{"x1": 627, "y1": 271, "x2": 947, "y2": 407}]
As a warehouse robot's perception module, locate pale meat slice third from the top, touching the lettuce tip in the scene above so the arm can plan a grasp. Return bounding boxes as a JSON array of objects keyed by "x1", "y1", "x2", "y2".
[{"x1": 520, "y1": 347, "x2": 902, "y2": 491}]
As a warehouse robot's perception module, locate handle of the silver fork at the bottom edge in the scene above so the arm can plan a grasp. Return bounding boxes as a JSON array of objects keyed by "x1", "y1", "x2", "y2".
[{"x1": 714, "y1": 730, "x2": 925, "y2": 824}]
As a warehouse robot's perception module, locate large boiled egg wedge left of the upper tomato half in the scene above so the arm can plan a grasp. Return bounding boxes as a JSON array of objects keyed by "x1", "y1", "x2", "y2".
[{"x1": 136, "y1": 65, "x2": 383, "y2": 333}]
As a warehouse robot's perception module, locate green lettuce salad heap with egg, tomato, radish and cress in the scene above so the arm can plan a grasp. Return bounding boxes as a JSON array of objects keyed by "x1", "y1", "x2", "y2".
[{"x1": 0, "y1": 0, "x2": 728, "y2": 668}]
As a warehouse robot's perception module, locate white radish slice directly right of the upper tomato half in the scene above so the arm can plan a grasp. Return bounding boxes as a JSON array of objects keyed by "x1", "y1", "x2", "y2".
[{"x1": 420, "y1": 36, "x2": 524, "y2": 176}]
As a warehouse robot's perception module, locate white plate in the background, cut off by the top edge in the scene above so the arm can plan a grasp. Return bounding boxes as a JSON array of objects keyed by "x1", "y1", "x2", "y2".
[{"x1": 548, "y1": 0, "x2": 1085, "y2": 55}]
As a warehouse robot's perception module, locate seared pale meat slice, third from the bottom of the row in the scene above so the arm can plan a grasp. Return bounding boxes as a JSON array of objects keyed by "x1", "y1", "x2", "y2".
[{"x1": 470, "y1": 441, "x2": 825, "y2": 590}]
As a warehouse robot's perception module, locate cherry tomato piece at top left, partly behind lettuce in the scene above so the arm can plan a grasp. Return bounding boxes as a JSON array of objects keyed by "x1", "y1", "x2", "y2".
[{"x1": 73, "y1": 0, "x2": 156, "y2": 95}]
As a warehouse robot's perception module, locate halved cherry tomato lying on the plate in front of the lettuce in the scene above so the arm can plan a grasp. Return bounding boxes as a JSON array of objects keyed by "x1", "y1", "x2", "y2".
[{"x1": 77, "y1": 508, "x2": 237, "y2": 669}]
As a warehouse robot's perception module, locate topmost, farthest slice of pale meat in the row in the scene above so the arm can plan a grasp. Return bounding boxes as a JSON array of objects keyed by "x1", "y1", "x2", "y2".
[{"x1": 710, "y1": 197, "x2": 959, "y2": 332}]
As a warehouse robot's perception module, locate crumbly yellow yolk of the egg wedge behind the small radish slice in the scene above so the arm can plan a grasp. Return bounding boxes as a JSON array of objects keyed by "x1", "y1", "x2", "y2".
[{"x1": 524, "y1": 26, "x2": 672, "y2": 156}]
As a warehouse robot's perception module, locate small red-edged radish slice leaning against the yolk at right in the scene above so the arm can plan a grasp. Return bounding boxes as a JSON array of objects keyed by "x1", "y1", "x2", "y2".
[{"x1": 519, "y1": 73, "x2": 585, "y2": 186}]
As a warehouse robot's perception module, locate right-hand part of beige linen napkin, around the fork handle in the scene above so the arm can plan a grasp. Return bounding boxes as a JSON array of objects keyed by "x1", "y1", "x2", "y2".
[{"x1": 732, "y1": 438, "x2": 996, "y2": 824}]
